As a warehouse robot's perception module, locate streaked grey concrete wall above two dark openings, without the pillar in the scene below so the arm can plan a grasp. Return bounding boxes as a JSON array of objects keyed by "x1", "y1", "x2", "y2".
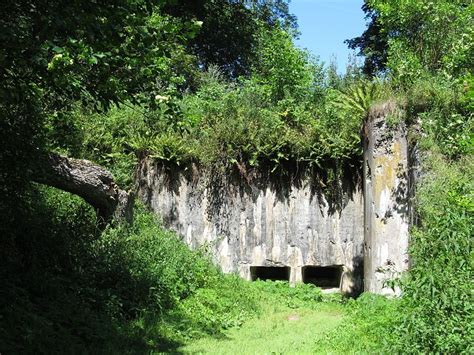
[{"x1": 139, "y1": 165, "x2": 364, "y2": 293}]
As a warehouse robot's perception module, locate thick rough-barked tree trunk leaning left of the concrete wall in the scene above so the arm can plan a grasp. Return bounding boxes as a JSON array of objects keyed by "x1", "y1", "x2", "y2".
[{"x1": 33, "y1": 153, "x2": 133, "y2": 223}]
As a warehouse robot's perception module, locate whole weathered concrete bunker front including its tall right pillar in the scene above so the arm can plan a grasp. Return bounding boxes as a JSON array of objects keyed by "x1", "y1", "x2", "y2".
[{"x1": 137, "y1": 102, "x2": 417, "y2": 295}]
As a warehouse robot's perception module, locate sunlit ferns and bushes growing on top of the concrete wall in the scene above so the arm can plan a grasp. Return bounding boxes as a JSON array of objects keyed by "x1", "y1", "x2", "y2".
[{"x1": 75, "y1": 53, "x2": 362, "y2": 178}]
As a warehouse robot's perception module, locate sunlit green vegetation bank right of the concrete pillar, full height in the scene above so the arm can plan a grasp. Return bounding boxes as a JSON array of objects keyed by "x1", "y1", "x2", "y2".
[{"x1": 324, "y1": 0, "x2": 474, "y2": 353}]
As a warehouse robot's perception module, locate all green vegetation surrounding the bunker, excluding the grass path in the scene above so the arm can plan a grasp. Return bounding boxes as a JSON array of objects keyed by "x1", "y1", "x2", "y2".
[{"x1": 0, "y1": 0, "x2": 474, "y2": 353}]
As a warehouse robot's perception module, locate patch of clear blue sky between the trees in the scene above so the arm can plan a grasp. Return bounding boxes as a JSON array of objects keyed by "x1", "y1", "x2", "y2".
[{"x1": 290, "y1": 0, "x2": 365, "y2": 72}]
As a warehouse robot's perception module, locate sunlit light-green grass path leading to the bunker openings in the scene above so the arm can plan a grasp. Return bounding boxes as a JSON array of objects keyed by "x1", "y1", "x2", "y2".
[{"x1": 179, "y1": 283, "x2": 344, "y2": 354}]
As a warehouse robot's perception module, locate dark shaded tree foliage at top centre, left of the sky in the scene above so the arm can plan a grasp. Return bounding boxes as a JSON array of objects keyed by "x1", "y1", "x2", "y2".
[{"x1": 164, "y1": 0, "x2": 297, "y2": 79}]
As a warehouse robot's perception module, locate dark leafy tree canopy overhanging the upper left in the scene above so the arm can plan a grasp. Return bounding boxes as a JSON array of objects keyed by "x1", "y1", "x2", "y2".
[{"x1": 0, "y1": 0, "x2": 296, "y2": 214}]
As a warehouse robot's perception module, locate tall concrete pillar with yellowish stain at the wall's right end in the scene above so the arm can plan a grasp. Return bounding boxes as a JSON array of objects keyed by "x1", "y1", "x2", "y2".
[{"x1": 364, "y1": 103, "x2": 409, "y2": 295}]
